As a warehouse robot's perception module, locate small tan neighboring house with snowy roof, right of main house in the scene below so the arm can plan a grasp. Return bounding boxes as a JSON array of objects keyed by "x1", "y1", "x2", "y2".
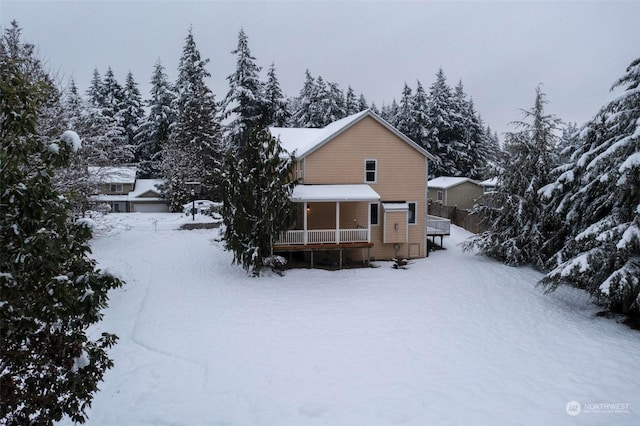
[{"x1": 428, "y1": 176, "x2": 484, "y2": 210}]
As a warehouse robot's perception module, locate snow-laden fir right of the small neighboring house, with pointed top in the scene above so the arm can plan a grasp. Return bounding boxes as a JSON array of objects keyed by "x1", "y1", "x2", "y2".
[{"x1": 464, "y1": 87, "x2": 560, "y2": 268}]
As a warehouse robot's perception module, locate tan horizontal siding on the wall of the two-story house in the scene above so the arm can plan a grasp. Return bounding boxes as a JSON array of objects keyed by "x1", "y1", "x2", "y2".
[{"x1": 304, "y1": 117, "x2": 427, "y2": 259}]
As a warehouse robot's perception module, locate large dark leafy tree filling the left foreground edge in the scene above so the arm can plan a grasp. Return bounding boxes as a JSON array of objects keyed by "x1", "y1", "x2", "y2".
[{"x1": 0, "y1": 22, "x2": 122, "y2": 425}]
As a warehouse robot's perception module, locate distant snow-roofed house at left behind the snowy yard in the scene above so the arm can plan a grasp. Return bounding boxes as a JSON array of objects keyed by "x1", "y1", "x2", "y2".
[{"x1": 89, "y1": 167, "x2": 169, "y2": 213}]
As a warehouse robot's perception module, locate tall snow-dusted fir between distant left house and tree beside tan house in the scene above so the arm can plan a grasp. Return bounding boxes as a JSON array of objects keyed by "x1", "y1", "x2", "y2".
[{"x1": 162, "y1": 29, "x2": 220, "y2": 211}]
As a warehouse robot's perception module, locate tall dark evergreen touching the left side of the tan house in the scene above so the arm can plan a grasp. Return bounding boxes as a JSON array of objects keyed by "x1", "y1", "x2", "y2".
[{"x1": 219, "y1": 31, "x2": 293, "y2": 276}]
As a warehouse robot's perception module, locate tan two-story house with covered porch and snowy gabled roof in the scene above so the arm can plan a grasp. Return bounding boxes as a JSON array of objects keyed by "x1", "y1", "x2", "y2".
[{"x1": 270, "y1": 110, "x2": 433, "y2": 263}]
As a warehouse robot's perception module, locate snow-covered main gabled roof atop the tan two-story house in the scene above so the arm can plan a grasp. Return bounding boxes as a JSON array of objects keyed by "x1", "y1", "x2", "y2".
[{"x1": 269, "y1": 109, "x2": 433, "y2": 160}]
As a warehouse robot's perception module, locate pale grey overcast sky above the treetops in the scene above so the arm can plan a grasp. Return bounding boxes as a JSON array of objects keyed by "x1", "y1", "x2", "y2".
[{"x1": 0, "y1": 0, "x2": 640, "y2": 138}]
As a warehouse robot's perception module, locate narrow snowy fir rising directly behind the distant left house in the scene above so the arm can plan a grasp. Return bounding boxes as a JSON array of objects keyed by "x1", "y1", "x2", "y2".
[{"x1": 134, "y1": 61, "x2": 177, "y2": 178}]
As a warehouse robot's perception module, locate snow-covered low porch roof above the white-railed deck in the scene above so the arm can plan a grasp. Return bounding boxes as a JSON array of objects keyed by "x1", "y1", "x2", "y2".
[{"x1": 291, "y1": 184, "x2": 380, "y2": 203}]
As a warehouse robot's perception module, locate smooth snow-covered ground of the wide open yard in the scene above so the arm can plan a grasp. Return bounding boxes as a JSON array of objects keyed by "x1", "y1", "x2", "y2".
[{"x1": 58, "y1": 213, "x2": 640, "y2": 426}]
